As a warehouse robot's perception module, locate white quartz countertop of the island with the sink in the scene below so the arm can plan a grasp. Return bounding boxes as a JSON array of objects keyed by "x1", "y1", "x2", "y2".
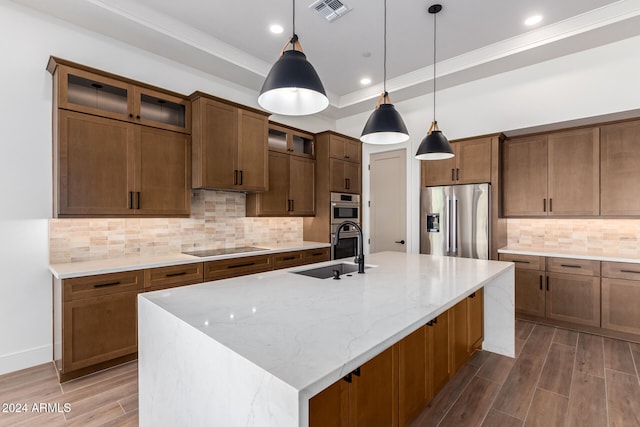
[{"x1": 138, "y1": 252, "x2": 514, "y2": 398}]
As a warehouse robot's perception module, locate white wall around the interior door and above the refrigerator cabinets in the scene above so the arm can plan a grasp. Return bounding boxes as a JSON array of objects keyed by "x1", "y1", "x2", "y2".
[{"x1": 336, "y1": 33, "x2": 640, "y2": 258}]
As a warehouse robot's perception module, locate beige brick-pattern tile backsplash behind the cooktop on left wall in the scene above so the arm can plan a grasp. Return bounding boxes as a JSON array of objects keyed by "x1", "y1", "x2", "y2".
[{"x1": 49, "y1": 190, "x2": 302, "y2": 264}]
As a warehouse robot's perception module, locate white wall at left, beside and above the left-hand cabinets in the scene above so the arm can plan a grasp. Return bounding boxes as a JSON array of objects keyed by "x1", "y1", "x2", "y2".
[{"x1": 0, "y1": 0, "x2": 335, "y2": 374}]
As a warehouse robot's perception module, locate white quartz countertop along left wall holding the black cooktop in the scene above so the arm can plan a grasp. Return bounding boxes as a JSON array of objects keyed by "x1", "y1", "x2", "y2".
[{"x1": 49, "y1": 241, "x2": 331, "y2": 279}]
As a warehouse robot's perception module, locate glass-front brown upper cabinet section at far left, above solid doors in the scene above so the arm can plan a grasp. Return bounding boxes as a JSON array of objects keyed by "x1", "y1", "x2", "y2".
[{"x1": 47, "y1": 57, "x2": 191, "y2": 133}]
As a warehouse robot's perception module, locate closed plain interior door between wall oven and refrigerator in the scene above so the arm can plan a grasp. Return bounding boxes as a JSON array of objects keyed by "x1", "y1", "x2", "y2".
[{"x1": 369, "y1": 149, "x2": 407, "y2": 253}]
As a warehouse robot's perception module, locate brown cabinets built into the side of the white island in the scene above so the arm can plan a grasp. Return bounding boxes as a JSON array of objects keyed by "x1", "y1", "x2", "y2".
[{"x1": 309, "y1": 289, "x2": 483, "y2": 427}]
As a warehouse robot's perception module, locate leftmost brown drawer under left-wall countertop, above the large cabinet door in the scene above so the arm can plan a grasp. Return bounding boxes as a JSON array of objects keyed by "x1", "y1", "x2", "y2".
[{"x1": 62, "y1": 270, "x2": 144, "y2": 301}]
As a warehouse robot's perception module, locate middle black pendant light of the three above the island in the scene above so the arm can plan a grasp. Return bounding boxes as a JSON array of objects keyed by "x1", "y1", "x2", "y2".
[{"x1": 360, "y1": 0, "x2": 409, "y2": 144}]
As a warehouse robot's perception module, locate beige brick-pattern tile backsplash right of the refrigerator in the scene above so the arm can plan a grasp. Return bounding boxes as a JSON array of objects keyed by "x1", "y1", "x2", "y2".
[{"x1": 507, "y1": 218, "x2": 640, "y2": 255}]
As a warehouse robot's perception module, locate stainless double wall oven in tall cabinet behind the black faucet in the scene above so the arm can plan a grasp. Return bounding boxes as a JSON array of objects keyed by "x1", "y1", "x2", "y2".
[{"x1": 330, "y1": 193, "x2": 360, "y2": 259}]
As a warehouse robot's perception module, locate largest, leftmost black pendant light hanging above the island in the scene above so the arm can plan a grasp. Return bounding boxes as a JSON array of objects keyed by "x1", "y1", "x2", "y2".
[{"x1": 258, "y1": 0, "x2": 329, "y2": 116}]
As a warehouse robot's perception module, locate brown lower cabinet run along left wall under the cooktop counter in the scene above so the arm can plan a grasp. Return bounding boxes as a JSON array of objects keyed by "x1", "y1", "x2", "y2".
[{"x1": 53, "y1": 248, "x2": 330, "y2": 382}]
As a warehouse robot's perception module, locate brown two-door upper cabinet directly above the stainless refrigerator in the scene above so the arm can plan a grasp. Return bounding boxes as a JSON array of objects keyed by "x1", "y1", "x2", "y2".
[{"x1": 421, "y1": 137, "x2": 492, "y2": 186}]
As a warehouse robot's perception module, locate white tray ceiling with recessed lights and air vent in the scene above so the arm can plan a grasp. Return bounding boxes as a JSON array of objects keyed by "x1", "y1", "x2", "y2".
[{"x1": 14, "y1": 0, "x2": 640, "y2": 117}]
